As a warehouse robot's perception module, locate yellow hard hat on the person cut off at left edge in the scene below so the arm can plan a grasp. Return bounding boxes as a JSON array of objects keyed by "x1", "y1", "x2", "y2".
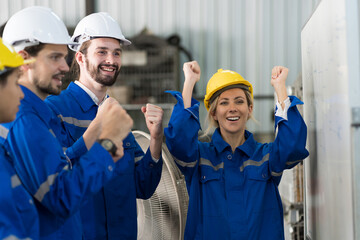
[{"x1": 0, "y1": 38, "x2": 35, "y2": 74}]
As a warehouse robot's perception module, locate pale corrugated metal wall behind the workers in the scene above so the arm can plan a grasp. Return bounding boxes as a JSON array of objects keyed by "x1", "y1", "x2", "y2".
[{"x1": 0, "y1": 0, "x2": 320, "y2": 132}]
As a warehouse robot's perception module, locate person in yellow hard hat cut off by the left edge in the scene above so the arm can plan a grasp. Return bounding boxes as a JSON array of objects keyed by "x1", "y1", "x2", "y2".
[{"x1": 0, "y1": 38, "x2": 39, "y2": 239}]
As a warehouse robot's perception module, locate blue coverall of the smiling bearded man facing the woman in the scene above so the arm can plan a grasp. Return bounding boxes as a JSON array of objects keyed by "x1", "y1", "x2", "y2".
[{"x1": 45, "y1": 82, "x2": 162, "y2": 240}]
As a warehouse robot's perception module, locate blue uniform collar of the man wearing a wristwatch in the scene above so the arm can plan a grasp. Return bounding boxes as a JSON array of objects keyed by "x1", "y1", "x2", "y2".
[{"x1": 20, "y1": 85, "x2": 53, "y2": 123}]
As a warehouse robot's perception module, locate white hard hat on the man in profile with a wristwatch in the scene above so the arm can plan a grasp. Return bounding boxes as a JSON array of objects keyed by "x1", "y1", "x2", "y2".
[{"x1": 3, "y1": 6, "x2": 74, "y2": 52}]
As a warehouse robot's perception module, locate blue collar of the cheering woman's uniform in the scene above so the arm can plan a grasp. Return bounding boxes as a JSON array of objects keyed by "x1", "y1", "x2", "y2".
[{"x1": 212, "y1": 128, "x2": 255, "y2": 157}]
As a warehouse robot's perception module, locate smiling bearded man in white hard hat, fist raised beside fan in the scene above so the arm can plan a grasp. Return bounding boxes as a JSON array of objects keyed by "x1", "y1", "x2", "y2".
[{"x1": 46, "y1": 12, "x2": 163, "y2": 240}]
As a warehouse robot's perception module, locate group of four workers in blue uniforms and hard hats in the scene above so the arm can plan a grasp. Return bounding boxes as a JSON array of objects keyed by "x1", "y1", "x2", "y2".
[{"x1": 0, "y1": 6, "x2": 308, "y2": 240}]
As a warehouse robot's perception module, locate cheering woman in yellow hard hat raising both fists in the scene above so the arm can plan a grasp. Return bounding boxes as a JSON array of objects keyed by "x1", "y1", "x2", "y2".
[{"x1": 165, "y1": 61, "x2": 308, "y2": 240}]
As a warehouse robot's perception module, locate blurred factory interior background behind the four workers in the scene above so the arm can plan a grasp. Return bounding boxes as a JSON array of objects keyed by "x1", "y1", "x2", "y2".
[{"x1": 0, "y1": 0, "x2": 360, "y2": 240}]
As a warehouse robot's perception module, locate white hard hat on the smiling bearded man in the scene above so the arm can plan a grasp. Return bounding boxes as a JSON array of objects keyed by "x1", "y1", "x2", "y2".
[{"x1": 69, "y1": 12, "x2": 131, "y2": 51}]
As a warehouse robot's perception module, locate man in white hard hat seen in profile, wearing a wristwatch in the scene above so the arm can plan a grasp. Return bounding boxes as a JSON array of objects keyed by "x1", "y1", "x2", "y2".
[{"x1": 3, "y1": 7, "x2": 132, "y2": 240}]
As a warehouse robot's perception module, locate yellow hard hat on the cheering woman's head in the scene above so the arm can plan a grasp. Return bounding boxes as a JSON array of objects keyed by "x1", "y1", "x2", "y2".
[{"x1": 204, "y1": 69, "x2": 254, "y2": 110}]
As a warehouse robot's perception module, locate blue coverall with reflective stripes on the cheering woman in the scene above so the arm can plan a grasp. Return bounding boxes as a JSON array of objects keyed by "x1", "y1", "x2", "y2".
[{"x1": 165, "y1": 91, "x2": 308, "y2": 240}]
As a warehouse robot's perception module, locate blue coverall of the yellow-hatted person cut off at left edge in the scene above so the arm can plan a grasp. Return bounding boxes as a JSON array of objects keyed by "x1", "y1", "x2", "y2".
[{"x1": 0, "y1": 130, "x2": 39, "y2": 240}]
